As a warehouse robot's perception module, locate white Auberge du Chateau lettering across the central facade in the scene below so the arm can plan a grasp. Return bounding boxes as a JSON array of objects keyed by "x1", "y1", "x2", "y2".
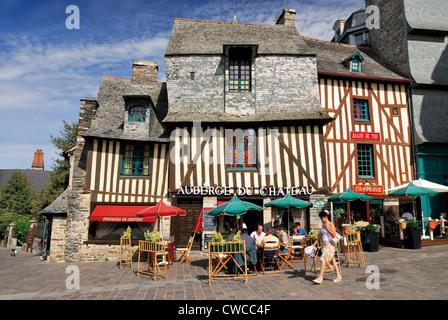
[{"x1": 176, "y1": 186, "x2": 314, "y2": 197}]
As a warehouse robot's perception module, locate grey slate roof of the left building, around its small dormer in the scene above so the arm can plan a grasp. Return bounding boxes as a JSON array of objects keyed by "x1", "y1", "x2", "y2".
[{"x1": 83, "y1": 75, "x2": 169, "y2": 142}]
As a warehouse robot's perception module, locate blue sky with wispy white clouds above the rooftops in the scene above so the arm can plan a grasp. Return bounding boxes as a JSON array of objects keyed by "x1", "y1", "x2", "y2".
[{"x1": 0, "y1": 0, "x2": 364, "y2": 170}]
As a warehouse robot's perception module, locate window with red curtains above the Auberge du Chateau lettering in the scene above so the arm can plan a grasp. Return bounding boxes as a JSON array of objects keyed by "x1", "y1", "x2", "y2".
[{"x1": 226, "y1": 129, "x2": 257, "y2": 169}]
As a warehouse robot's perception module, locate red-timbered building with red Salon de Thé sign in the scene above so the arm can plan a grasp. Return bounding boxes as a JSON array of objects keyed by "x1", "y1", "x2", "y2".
[{"x1": 304, "y1": 38, "x2": 414, "y2": 222}]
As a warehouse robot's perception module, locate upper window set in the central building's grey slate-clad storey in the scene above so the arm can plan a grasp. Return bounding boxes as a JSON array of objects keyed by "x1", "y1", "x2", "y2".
[{"x1": 229, "y1": 48, "x2": 252, "y2": 92}]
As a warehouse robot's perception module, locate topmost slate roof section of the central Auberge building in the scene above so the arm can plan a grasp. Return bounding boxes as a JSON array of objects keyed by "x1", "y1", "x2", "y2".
[{"x1": 165, "y1": 18, "x2": 314, "y2": 56}]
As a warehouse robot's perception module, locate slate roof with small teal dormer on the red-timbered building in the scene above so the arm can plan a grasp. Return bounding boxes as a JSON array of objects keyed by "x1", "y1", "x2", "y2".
[{"x1": 302, "y1": 36, "x2": 408, "y2": 81}]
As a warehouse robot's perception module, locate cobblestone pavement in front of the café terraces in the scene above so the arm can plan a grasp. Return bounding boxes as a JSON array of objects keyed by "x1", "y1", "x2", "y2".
[{"x1": 0, "y1": 245, "x2": 448, "y2": 301}]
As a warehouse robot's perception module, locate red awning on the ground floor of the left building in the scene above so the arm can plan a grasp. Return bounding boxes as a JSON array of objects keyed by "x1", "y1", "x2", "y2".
[{"x1": 89, "y1": 205, "x2": 156, "y2": 222}]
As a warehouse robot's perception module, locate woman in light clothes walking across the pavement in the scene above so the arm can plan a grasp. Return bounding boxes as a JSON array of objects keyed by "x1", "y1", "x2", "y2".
[{"x1": 313, "y1": 210, "x2": 342, "y2": 284}]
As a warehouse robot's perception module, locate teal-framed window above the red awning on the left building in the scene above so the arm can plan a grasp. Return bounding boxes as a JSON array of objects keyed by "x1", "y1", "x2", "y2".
[{"x1": 121, "y1": 144, "x2": 149, "y2": 176}]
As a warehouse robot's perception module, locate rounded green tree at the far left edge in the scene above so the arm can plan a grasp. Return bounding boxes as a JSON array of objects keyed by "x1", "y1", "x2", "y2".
[{"x1": 0, "y1": 170, "x2": 35, "y2": 230}]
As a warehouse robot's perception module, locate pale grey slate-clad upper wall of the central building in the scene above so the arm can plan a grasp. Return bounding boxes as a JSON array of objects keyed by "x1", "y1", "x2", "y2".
[{"x1": 165, "y1": 55, "x2": 320, "y2": 114}]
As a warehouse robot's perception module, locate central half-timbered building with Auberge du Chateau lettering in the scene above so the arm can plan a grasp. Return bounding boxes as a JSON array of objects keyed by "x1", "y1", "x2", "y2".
[{"x1": 163, "y1": 9, "x2": 331, "y2": 243}]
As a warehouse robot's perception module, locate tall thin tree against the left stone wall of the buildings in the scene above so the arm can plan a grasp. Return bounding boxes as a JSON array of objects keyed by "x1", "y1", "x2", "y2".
[{"x1": 34, "y1": 121, "x2": 78, "y2": 213}]
